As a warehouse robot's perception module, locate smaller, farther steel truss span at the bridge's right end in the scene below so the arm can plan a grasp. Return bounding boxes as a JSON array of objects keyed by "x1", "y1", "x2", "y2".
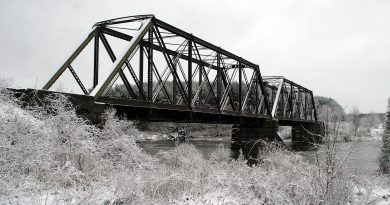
[{"x1": 263, "y1": 76, "x2": 317, "y2": 121}]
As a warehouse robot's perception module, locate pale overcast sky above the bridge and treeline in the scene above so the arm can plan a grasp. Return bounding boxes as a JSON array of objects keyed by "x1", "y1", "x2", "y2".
[{"x1": 0, "y1": 0, "x2": 390, "y2": 112}]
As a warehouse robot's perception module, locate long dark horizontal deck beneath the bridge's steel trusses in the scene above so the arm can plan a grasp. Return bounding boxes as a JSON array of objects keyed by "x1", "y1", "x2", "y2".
[{"x1": 11, "y1": 89, "x2": 317, "y2": 126}]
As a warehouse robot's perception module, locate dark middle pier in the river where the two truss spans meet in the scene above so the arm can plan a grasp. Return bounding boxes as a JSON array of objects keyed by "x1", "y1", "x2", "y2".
[{"x1": 231, "y1": 120, "x2": 279, "y2": 165}]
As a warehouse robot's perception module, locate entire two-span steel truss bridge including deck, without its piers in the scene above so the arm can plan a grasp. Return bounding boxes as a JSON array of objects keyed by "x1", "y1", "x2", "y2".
[{"x1": 15, "y1": 15, "x2": 320, "y2": 143}]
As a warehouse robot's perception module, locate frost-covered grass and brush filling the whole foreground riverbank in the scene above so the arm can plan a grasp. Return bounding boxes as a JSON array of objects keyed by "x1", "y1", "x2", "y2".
[{"x1": 0, "y1": 82, "x2": 388, "y2": 204}]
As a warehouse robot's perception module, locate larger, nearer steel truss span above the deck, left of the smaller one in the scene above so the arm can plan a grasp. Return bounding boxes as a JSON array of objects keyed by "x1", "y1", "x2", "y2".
[{"x1": 43, "y1": 15, "x2": 271, "y2": 116}]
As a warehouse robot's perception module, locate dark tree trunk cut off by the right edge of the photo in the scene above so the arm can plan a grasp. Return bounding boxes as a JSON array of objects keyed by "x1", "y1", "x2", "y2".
[{"x1": 379, "y1": 98, "x2": 390, "y2": 174}]
